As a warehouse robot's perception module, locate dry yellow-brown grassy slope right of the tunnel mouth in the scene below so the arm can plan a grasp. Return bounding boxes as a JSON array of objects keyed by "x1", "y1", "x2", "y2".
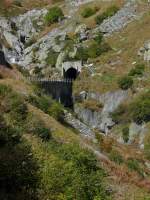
[{"x1": 75, "y1": 0, "x2": 150, "y2": 92}]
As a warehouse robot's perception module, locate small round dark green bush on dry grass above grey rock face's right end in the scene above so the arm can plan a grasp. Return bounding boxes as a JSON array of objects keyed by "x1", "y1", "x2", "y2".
[{"x1": 118, "y1": 76, "x2": 133, "y2": 90}]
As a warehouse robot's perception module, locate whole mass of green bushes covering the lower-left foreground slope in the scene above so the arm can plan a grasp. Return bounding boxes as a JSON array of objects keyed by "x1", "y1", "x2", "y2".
[{"x1": 0, "y1": 85, "x2": 110, "y2": 200}]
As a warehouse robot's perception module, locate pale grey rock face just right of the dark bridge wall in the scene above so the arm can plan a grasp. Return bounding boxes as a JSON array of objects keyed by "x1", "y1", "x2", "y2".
[{"x1": 75, "y1": 90, "x2": 128, "y2": 134}]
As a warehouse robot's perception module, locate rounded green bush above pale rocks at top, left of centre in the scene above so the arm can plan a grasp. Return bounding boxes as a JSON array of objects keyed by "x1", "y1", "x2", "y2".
[{"x1": 45, "y1": 6, "x2": 64, "y2": 24}]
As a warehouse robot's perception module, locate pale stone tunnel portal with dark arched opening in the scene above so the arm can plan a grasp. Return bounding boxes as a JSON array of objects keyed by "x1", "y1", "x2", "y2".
[{"x1": 62, "y1": 61, "x2": 82, "y2": 79}]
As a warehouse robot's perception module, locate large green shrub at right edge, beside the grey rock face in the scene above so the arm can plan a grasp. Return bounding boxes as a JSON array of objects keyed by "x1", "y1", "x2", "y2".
[{"x1": 129, "y1": 92, "x2": 150, "y2": 124}]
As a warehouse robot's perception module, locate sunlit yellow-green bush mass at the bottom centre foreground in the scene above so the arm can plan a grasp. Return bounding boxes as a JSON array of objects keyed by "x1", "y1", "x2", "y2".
[{"x1": 39, "y1": 142, "x2": 110, "y2": 200}]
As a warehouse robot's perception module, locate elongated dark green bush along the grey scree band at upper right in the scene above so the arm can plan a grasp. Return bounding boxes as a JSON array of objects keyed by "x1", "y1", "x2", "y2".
[{"x1": 95, "y1": 6, "x2": 119, "y2": 24}]
